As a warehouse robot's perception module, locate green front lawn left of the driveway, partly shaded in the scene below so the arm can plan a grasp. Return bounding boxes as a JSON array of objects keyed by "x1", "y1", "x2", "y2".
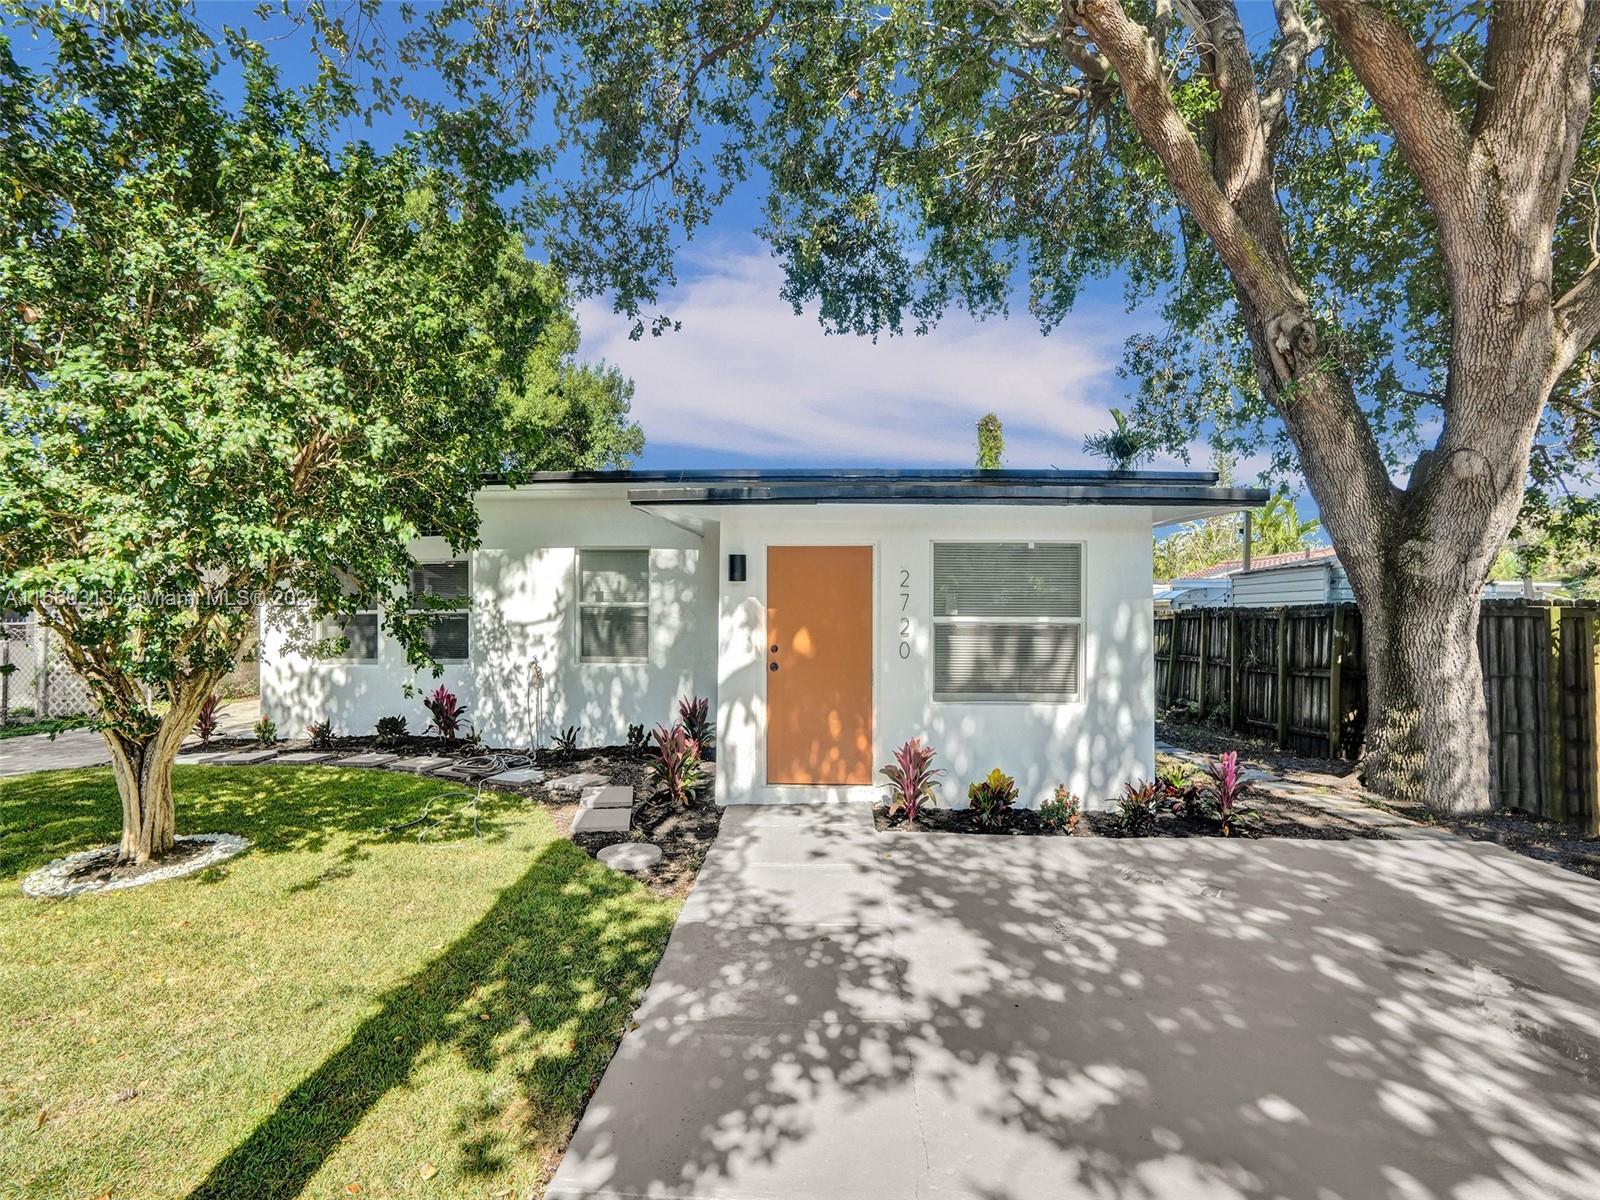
[{"x1": 0, "y1": 766, "x2": 677, "y2": 1200}]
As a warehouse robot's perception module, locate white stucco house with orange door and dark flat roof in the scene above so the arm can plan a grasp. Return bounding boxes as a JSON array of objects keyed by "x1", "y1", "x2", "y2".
[{"x1": 261, "y1": 470, "x2": 1266, "y2": 806}]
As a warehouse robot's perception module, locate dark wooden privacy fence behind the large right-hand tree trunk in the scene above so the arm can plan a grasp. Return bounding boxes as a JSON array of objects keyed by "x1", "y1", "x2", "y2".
[{"x1": 1155, "y1": 600, "x2": 1600, "y2": 829}]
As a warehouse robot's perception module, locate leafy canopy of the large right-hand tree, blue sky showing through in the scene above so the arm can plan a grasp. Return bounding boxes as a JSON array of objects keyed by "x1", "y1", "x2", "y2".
[{"x1": 305, "y1": 0, "x2": 1600, "y2": 531}]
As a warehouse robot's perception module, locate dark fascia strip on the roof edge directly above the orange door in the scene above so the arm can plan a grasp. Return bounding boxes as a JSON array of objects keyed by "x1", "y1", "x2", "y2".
[{"x1": 627, "y1": 482, "x2": 1272, "y2": 509}]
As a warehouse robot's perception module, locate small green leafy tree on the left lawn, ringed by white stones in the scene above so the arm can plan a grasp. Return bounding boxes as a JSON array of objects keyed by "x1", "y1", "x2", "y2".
[{"x1": 0, "y1": 3, "x2": 637, "y2": 862}]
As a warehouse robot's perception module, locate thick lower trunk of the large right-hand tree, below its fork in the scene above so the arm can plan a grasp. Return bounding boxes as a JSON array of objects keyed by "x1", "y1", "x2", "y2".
[{"x1": 1362, "y1": 579, "x2": 1491, "y2": 813}]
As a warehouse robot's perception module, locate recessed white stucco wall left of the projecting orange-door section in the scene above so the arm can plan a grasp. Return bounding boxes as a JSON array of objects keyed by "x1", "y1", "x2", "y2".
[{"x1": 261, "y1": 488, "x2": 718, "y2": 747}]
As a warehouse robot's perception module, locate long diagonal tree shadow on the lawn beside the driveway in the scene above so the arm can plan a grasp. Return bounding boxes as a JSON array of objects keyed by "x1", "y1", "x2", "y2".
[{"x1": 189, "y1": 842, "x2": 672, "y2": 1200}]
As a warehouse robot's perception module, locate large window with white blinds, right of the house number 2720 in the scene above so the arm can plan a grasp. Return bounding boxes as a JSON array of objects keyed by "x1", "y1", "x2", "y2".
[{"x1": 933, "y1": 542, "x2": 1083, "y2": 701}]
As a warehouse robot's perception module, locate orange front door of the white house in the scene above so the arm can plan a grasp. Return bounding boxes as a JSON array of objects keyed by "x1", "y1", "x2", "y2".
[{"x1": 766, "y1": 546, "x2": 872, "y2": 784}]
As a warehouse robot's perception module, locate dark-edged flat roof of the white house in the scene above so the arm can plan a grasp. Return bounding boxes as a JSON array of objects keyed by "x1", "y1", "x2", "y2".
[{"x1": 492, "y1": 467, "x2": 1270, "y2": 510}]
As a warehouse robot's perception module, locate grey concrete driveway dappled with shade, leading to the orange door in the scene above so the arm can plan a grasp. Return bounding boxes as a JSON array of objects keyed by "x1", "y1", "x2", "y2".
[{"x1": 547, "y1": 808, "x2": 1600, "y2": 1200}]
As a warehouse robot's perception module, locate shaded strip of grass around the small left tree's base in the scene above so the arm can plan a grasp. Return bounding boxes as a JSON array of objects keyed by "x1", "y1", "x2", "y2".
[{"x1": 0, "y1": 766, "x2": 506, "y2": 878}]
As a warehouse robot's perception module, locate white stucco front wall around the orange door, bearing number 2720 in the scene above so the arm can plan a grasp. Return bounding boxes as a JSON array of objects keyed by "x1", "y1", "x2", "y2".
[{"x1": 715, "y1": 504, "x2": 1155, "y2": 806}]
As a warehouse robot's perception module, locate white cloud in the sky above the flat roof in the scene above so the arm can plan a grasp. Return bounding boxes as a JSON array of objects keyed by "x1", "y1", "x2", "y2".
[{"x1": 579, "y1": 245, "x2": 1177, "y2": 467}]
